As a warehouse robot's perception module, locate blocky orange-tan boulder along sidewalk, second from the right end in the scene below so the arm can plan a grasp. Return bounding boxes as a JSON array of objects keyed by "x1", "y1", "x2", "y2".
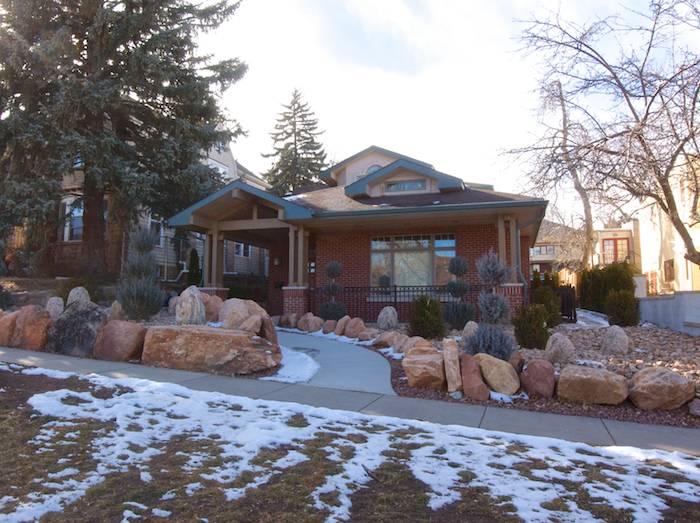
[{"x1": 557, "y1": 365, "x2": 628, "y2": 405}]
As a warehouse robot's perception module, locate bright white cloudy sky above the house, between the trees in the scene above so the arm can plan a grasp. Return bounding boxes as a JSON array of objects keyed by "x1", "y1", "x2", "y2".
[{"x1": 201, "y1": 0, "x2": 644, "y2": 199}]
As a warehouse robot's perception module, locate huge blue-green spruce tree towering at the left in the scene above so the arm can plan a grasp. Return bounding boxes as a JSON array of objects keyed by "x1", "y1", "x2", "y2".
[{"x1": 0, "y1": 0, "x2": 246, "y2": 275}]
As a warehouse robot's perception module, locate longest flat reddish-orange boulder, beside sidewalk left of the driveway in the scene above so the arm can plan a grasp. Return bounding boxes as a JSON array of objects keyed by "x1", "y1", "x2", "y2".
[{"x1": 141, "y1": 325, "x2": 282, "y2": 376}]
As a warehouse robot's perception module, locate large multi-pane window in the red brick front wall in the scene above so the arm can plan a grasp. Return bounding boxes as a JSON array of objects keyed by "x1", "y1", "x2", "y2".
[{"x1": 371, "y1": 234, "x2": 455, "y2": 286}]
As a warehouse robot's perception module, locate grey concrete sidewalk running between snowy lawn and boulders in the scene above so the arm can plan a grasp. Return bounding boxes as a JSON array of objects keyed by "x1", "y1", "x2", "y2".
[{"x1": 0, "y1": 348, "x2": 700, "y2": 456}]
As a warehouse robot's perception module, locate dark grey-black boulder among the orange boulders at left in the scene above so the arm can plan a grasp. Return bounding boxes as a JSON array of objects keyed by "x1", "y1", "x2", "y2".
[{"x1": 46, "y1": 301, "x2": 107, "y2": 358}]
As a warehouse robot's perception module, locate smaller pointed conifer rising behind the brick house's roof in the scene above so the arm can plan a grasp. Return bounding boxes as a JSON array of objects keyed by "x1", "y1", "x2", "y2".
[{"x1": 263, "y1": 89, "x2": 326, "y2": 195}]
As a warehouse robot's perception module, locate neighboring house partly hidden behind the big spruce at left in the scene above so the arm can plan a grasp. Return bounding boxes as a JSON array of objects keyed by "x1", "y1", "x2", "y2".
[{"x1": 53, "y1": 148, "x2": 269, "y2": 283}]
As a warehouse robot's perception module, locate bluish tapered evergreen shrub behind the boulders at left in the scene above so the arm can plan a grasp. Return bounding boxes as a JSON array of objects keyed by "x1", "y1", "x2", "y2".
[{"x1": 117, "y1": 229, "x2": 165, "y2": 320}]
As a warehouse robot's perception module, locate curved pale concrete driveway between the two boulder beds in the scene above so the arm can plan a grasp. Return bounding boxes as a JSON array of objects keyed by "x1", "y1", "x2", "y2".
[{"x1": 277, "y1": 331, "x2": 396, "y2": 396}]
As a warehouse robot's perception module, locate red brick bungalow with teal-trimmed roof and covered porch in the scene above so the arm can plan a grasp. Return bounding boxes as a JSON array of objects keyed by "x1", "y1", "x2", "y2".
[{"x1": 168, "y1": 146, "x2": 547, "y2": 320}]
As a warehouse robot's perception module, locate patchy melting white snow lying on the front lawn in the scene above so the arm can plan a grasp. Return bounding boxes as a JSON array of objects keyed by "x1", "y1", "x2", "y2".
[{"x1": 0, "y1": 364, "x2": 700, "y2": 521}]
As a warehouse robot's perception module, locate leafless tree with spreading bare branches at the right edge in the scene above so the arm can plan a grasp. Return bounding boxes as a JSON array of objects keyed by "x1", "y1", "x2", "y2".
[{"x1": 522, "y1": 0, "x2": 700, "y2": 264}]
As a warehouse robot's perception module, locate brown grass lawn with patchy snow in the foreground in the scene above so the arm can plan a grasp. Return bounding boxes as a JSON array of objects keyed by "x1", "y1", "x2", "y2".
[{"x1": 0, "y1": 364, "x2": 700, "y2": 522}]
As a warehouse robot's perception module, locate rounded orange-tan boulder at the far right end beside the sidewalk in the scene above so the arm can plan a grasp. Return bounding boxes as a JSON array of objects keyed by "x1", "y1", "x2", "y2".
[{"x1": 629, "y1": 367, "x2": 695, "y2": 410}]
